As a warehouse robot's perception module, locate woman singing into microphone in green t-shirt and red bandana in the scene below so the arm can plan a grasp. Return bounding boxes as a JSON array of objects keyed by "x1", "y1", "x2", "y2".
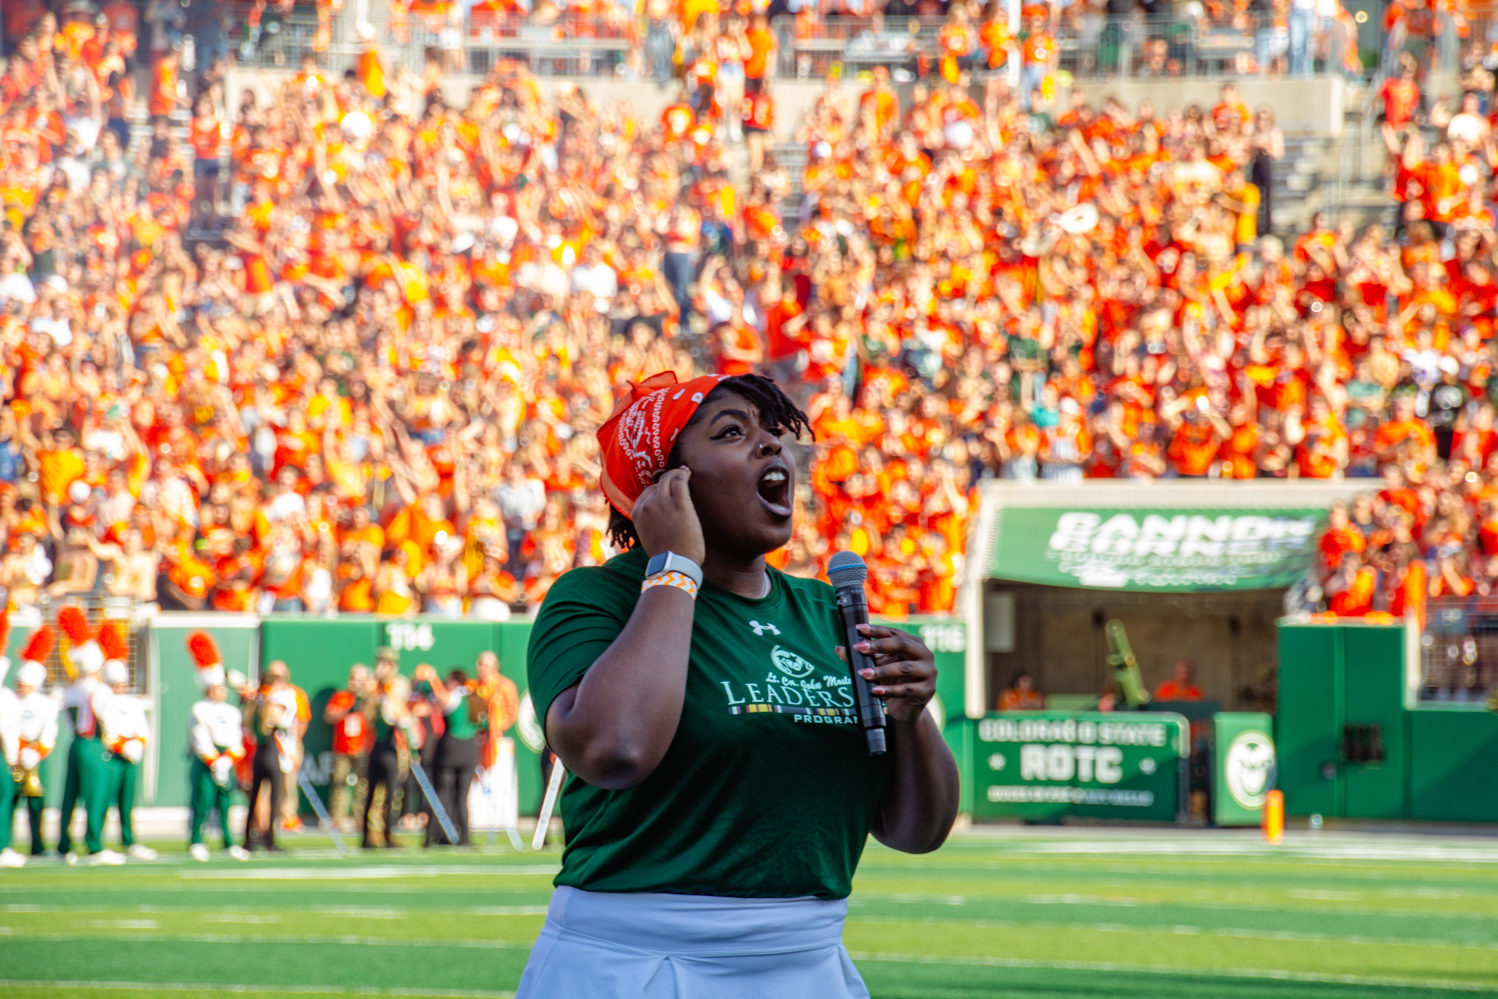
[{"x1": 517, "y1": 373, "x2": 957, "y2": 999}]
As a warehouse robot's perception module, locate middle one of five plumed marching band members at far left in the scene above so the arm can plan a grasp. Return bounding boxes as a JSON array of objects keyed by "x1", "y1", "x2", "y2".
[{"x1": 57, "y1": 607, "x2": 124, "y2": 864}]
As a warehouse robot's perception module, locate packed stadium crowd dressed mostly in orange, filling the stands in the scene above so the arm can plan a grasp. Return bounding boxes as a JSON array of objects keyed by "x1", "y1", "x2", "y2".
[{"x1": 0, "y1": 3, "x2": 1498, "y2": 620}]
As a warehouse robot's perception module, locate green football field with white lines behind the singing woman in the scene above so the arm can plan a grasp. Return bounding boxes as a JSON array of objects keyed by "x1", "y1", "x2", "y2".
[{"x1": 0, "y1": 828, "x2": 1498, "y2": 999}]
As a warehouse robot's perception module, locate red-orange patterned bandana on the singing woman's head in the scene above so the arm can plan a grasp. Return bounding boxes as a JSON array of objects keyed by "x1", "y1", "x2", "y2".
[{"x1": 598, "y1": 371, "x2": 724, "y2": 517}]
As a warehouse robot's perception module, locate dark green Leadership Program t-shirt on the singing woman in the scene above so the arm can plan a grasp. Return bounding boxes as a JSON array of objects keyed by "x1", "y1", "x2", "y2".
[{"x1": 529, "y1": 547, "x2": 890, "y2": 899}]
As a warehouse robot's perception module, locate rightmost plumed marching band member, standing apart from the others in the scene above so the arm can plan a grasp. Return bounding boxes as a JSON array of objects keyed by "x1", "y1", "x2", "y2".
[{"x1": 187, "y1": 632, "x2": 250, "y2": 860}]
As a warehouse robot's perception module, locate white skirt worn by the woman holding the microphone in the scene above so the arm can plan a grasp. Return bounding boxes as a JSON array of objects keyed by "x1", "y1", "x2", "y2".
[{"x1": 515, "y1": 887, "x2": 869, "y2": 999}]
